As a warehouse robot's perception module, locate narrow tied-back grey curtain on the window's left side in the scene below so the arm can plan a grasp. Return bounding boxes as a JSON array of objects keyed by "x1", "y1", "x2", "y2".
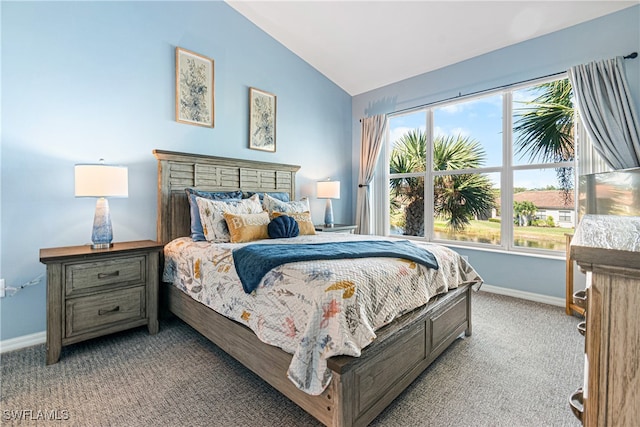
[{"x1": 356, "y1": 114, "x2": 387, "y2": 234}]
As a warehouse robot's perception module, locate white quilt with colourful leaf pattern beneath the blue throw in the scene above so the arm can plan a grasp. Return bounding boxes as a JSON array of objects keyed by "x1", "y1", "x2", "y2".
[{"x1": 163, "y1": 233, "x2": 482, "y2": 395}]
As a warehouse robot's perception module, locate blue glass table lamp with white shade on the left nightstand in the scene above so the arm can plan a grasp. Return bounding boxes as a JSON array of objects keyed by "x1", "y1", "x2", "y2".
[{"x1": 75, "y1": 159, "x2": 129, "y2": 249}]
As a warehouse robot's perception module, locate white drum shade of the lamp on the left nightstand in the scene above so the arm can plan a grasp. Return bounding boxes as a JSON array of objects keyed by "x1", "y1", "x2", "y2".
[{"x1": 75, "y1": 164, "x2": 129, "y2": 197}]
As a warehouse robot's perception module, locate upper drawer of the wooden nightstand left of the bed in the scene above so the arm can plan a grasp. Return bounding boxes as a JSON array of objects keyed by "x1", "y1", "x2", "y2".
[{"x1": 65, "y1": 256, "x2": 145, "y2": 295}]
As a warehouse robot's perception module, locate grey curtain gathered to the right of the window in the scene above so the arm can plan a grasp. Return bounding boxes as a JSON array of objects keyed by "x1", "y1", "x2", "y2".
[{"x1": 569, "y1": 56, "x2": 640, "y2": 169}]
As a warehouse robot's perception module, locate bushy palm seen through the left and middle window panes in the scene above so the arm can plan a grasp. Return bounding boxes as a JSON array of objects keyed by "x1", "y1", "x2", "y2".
[{"x1": 389, "y1": 129, "x2": 494, "y2": 236}]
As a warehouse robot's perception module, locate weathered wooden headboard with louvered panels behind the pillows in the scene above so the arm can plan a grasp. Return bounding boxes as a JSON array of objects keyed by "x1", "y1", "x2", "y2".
[{"x1": 153, "y1": 150, "x2": 300, "y2": 243}]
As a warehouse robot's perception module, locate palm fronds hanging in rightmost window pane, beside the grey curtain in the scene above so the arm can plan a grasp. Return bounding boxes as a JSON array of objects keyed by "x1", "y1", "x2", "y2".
[{"x1": 513, "y1": 79, "x2": 575, "y2": 197}]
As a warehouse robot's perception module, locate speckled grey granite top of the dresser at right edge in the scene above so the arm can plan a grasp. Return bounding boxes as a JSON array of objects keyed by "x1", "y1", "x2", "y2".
[{"x1": 571, "y1": 215, "x2": 640, "y2": 269}]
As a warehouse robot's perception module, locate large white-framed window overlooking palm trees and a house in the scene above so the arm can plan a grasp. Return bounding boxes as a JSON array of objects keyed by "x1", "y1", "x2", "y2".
[{"x1": 386, "y1": 78, "x2": 575, "y2": 251}]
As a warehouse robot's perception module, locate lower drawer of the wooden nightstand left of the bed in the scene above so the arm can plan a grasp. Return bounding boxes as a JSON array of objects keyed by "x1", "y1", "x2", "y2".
[{"x1": 65, "y1": 286, "x2": 146, "y2": 338}]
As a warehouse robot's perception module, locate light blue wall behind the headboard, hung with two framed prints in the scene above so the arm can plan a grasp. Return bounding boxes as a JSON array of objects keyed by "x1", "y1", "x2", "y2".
[{"x1": 0, "y1": 1, "x2": 353, "y2": 340}]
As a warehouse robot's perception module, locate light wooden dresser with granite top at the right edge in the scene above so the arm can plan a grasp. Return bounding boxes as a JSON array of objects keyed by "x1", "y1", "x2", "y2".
[{"x1": 570, "y1": 215, "x2": 640, "y2": 426}]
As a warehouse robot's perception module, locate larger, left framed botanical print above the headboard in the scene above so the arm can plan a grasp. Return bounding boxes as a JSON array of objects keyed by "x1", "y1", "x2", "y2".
[{"x1": 176, "y1": 47, "x2": 215, "y2": 127}]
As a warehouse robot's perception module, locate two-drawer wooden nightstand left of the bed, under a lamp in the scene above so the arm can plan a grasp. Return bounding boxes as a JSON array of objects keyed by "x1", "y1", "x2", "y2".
[{"x1": 40, "y1": 240, "x2": 163, "y2": 365}]
